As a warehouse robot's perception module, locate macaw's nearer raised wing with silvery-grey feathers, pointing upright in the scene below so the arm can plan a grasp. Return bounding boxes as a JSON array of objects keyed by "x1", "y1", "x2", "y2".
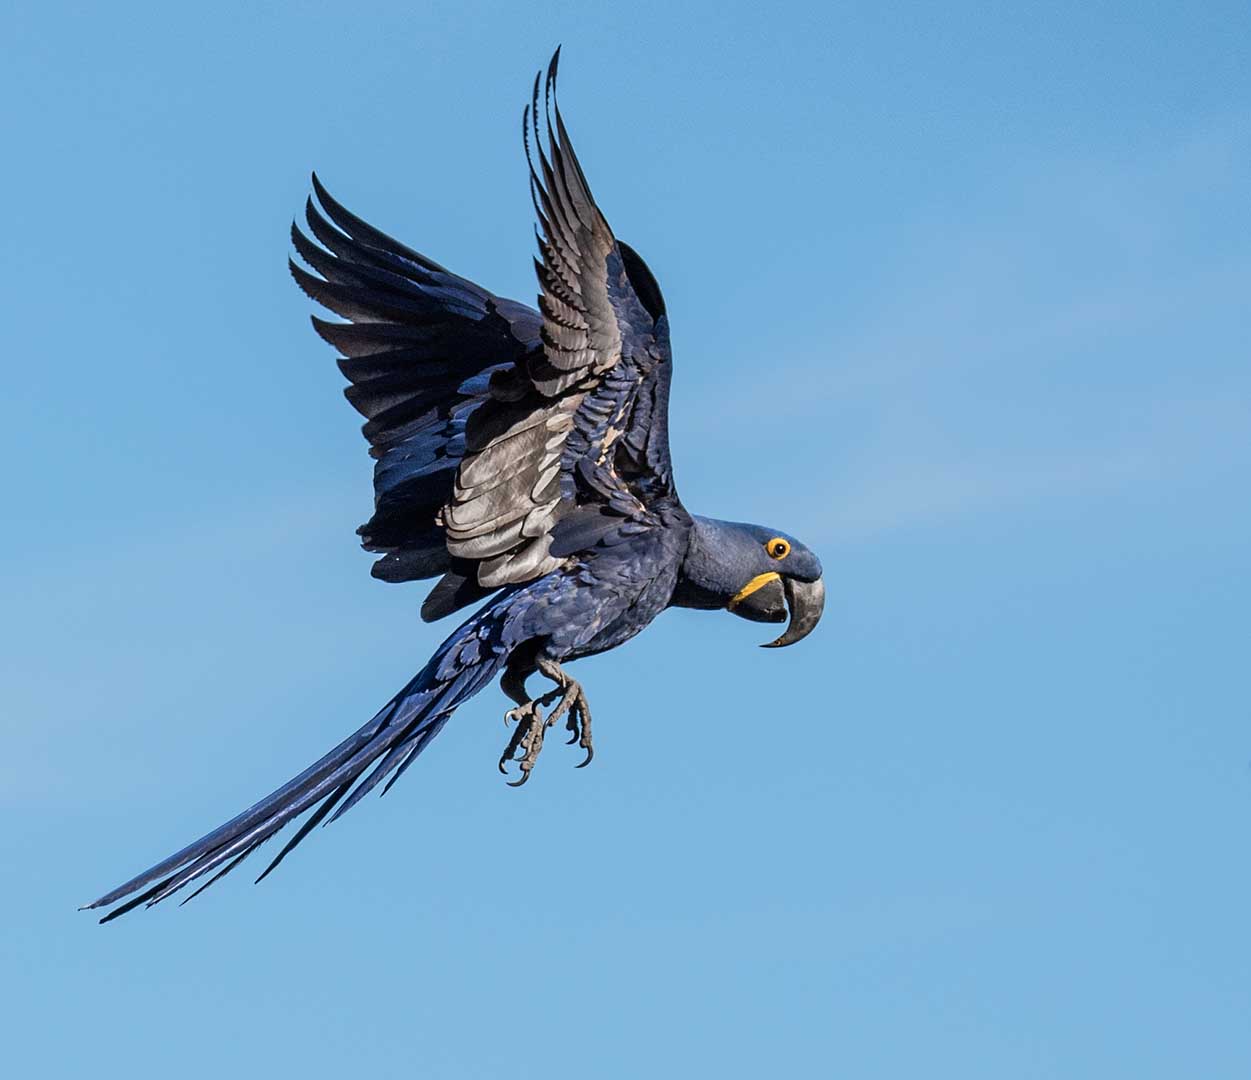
[{"x1": 444, "y1": 50, "x2": 674, "y2": 587}]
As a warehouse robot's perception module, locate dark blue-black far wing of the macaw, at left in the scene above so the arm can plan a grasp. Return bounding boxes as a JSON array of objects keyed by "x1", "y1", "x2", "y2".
[{"x1": 290, "y1": 175, "x2": 542, "y2": 600}]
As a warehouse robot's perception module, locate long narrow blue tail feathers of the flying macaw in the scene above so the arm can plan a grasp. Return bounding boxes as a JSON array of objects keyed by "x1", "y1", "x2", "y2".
[{"x1": 86, "y1": 601, "x2": 508, "y2": 922}]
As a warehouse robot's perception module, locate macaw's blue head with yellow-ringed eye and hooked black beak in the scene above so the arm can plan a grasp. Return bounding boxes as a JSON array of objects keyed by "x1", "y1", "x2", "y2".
[{"x1": 673, "y1": 517, "x2": 826, "y2": 648}]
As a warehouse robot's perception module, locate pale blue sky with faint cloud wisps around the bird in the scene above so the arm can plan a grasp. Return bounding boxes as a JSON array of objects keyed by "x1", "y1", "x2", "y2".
[{"x1": 0, "y1": 0, "x2": 1251, "y2": 1080}]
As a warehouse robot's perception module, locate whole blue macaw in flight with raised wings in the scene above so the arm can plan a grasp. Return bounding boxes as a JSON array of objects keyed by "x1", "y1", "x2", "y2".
[{"x1": 88, "y1": 49, "x2": 824, "y2": 922}]
